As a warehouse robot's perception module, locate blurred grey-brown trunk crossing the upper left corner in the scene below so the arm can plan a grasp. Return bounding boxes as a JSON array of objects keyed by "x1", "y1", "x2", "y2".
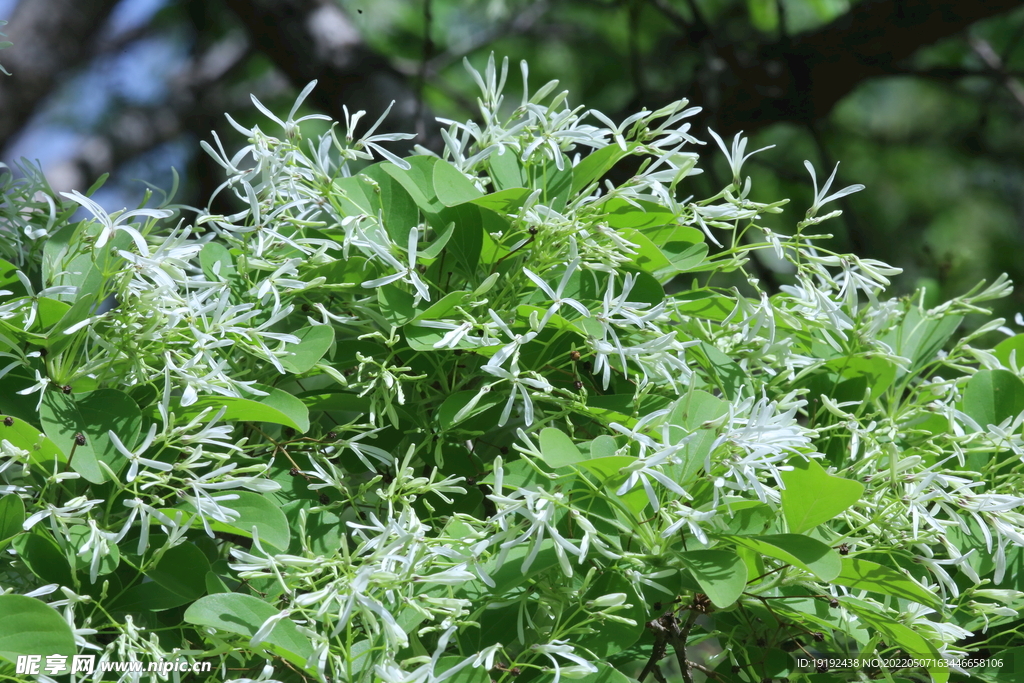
[{"x1": 0, "y1": 0, "x2": 118, "y2": 147}]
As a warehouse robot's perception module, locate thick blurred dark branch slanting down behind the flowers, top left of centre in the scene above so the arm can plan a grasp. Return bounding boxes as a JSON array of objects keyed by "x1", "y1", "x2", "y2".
[{"x1": 225, "y1": 0, "x2": 439, "y2": 147}]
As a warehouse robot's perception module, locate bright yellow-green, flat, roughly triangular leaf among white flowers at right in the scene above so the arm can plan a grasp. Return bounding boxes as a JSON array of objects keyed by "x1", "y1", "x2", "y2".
[{"x1": 781, "y1": 459, "x2": 864, "y2": 533}]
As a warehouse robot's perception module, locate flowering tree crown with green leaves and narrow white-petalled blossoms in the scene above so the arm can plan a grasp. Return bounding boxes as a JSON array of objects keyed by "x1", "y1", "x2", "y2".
[{"x1": 0, "y1": 60, "x2": 1024, "y2": 683}]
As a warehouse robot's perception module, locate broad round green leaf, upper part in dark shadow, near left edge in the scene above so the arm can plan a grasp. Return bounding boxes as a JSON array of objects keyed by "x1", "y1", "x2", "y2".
[{"x1": 39, "y1": 389, "x2": 142, "y2": 483}]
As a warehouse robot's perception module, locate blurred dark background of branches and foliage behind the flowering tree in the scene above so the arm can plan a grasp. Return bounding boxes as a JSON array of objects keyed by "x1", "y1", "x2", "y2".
[{"x1": 0, "y1": 0, "x2": 1024, "y2": 314}]
